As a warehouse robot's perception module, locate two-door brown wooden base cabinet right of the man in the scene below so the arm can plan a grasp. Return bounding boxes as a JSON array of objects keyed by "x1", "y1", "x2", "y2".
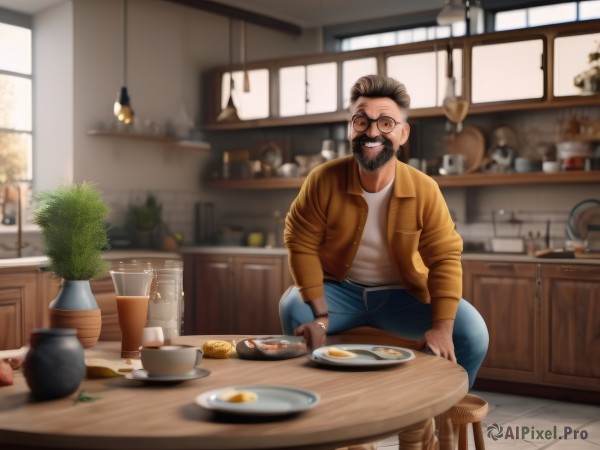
[{"x1": 463, "y1": 261, "x2": 600, "y2": 391}]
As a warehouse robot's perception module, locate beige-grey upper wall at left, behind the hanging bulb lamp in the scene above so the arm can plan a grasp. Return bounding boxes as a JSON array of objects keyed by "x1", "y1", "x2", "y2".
[{"x1": 34, "y1": 0, "x2": 317, "y2": 243}]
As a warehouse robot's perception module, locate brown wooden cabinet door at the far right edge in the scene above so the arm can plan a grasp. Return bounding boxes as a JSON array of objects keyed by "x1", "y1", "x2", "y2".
[{"x1": 541, "y1": 264, "x2": 600, "y2": 390}]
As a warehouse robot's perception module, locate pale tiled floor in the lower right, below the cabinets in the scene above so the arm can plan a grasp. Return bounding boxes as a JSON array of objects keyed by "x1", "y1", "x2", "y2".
[{"x1": 378, "y1": 391, "x2": 600, "y2": 450}]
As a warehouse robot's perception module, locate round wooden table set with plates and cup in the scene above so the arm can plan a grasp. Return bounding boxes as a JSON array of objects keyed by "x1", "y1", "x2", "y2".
[{"x1": 0, "y1": 336, "x2": 468, "y2": 450}]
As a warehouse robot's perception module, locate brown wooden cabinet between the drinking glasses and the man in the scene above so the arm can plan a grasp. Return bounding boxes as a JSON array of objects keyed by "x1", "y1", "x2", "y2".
[{"x1": 184, "y1": 254, "x2": 289, "y2": 334}]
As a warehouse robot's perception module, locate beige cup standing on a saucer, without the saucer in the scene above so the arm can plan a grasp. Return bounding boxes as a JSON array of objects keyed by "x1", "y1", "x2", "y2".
[{"x1": 141, "y1": 345, "x2": 202, "y2": 376}]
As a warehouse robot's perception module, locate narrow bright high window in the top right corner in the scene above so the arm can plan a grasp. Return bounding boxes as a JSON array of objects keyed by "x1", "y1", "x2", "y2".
[{"x1": 494, "y1": 0, "x2": 600, "y2": 31}]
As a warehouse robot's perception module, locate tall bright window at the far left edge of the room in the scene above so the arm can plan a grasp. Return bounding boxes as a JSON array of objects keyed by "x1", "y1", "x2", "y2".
[{"x1": 0, "y1": 22, "x2": 33, "y2": 183}]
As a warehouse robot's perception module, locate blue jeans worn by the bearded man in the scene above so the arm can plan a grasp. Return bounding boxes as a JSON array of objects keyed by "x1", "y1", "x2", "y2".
[{"x1": 279, "y1": 280, "x2": 489, "y2": 387}]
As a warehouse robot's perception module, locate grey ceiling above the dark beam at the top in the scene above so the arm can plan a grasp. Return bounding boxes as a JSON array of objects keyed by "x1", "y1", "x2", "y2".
[{"x1": 0, "y1": 0, "x2": 444, "y2": 28}]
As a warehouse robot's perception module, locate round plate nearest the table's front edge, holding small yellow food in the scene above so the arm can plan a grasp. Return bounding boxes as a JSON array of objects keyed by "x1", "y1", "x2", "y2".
[{"x1": 196, "y1": 385, "x2": 320, "y2": 416}]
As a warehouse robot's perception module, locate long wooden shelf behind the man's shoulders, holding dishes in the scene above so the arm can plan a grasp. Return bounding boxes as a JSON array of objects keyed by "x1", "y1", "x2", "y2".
[{"x1": 205, "y1": 170, "x2": 600, "y2": 190}]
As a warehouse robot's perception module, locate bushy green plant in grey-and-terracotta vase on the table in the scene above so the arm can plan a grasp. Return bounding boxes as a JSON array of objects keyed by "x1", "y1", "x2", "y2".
[{"x1": 33, "y1": 182, "x2": 109, "y2": 347}]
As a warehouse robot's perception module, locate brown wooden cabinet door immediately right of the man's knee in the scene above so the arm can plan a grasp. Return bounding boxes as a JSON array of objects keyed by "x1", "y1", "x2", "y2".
[{"x1": 463, "y1": 261, "x2": 542, "y2": 382}]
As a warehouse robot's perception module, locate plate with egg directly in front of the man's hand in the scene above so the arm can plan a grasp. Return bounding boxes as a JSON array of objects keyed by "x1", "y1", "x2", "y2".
[{"x1": 310, "y1": 344, "x2": 415, "y2": 367}]
